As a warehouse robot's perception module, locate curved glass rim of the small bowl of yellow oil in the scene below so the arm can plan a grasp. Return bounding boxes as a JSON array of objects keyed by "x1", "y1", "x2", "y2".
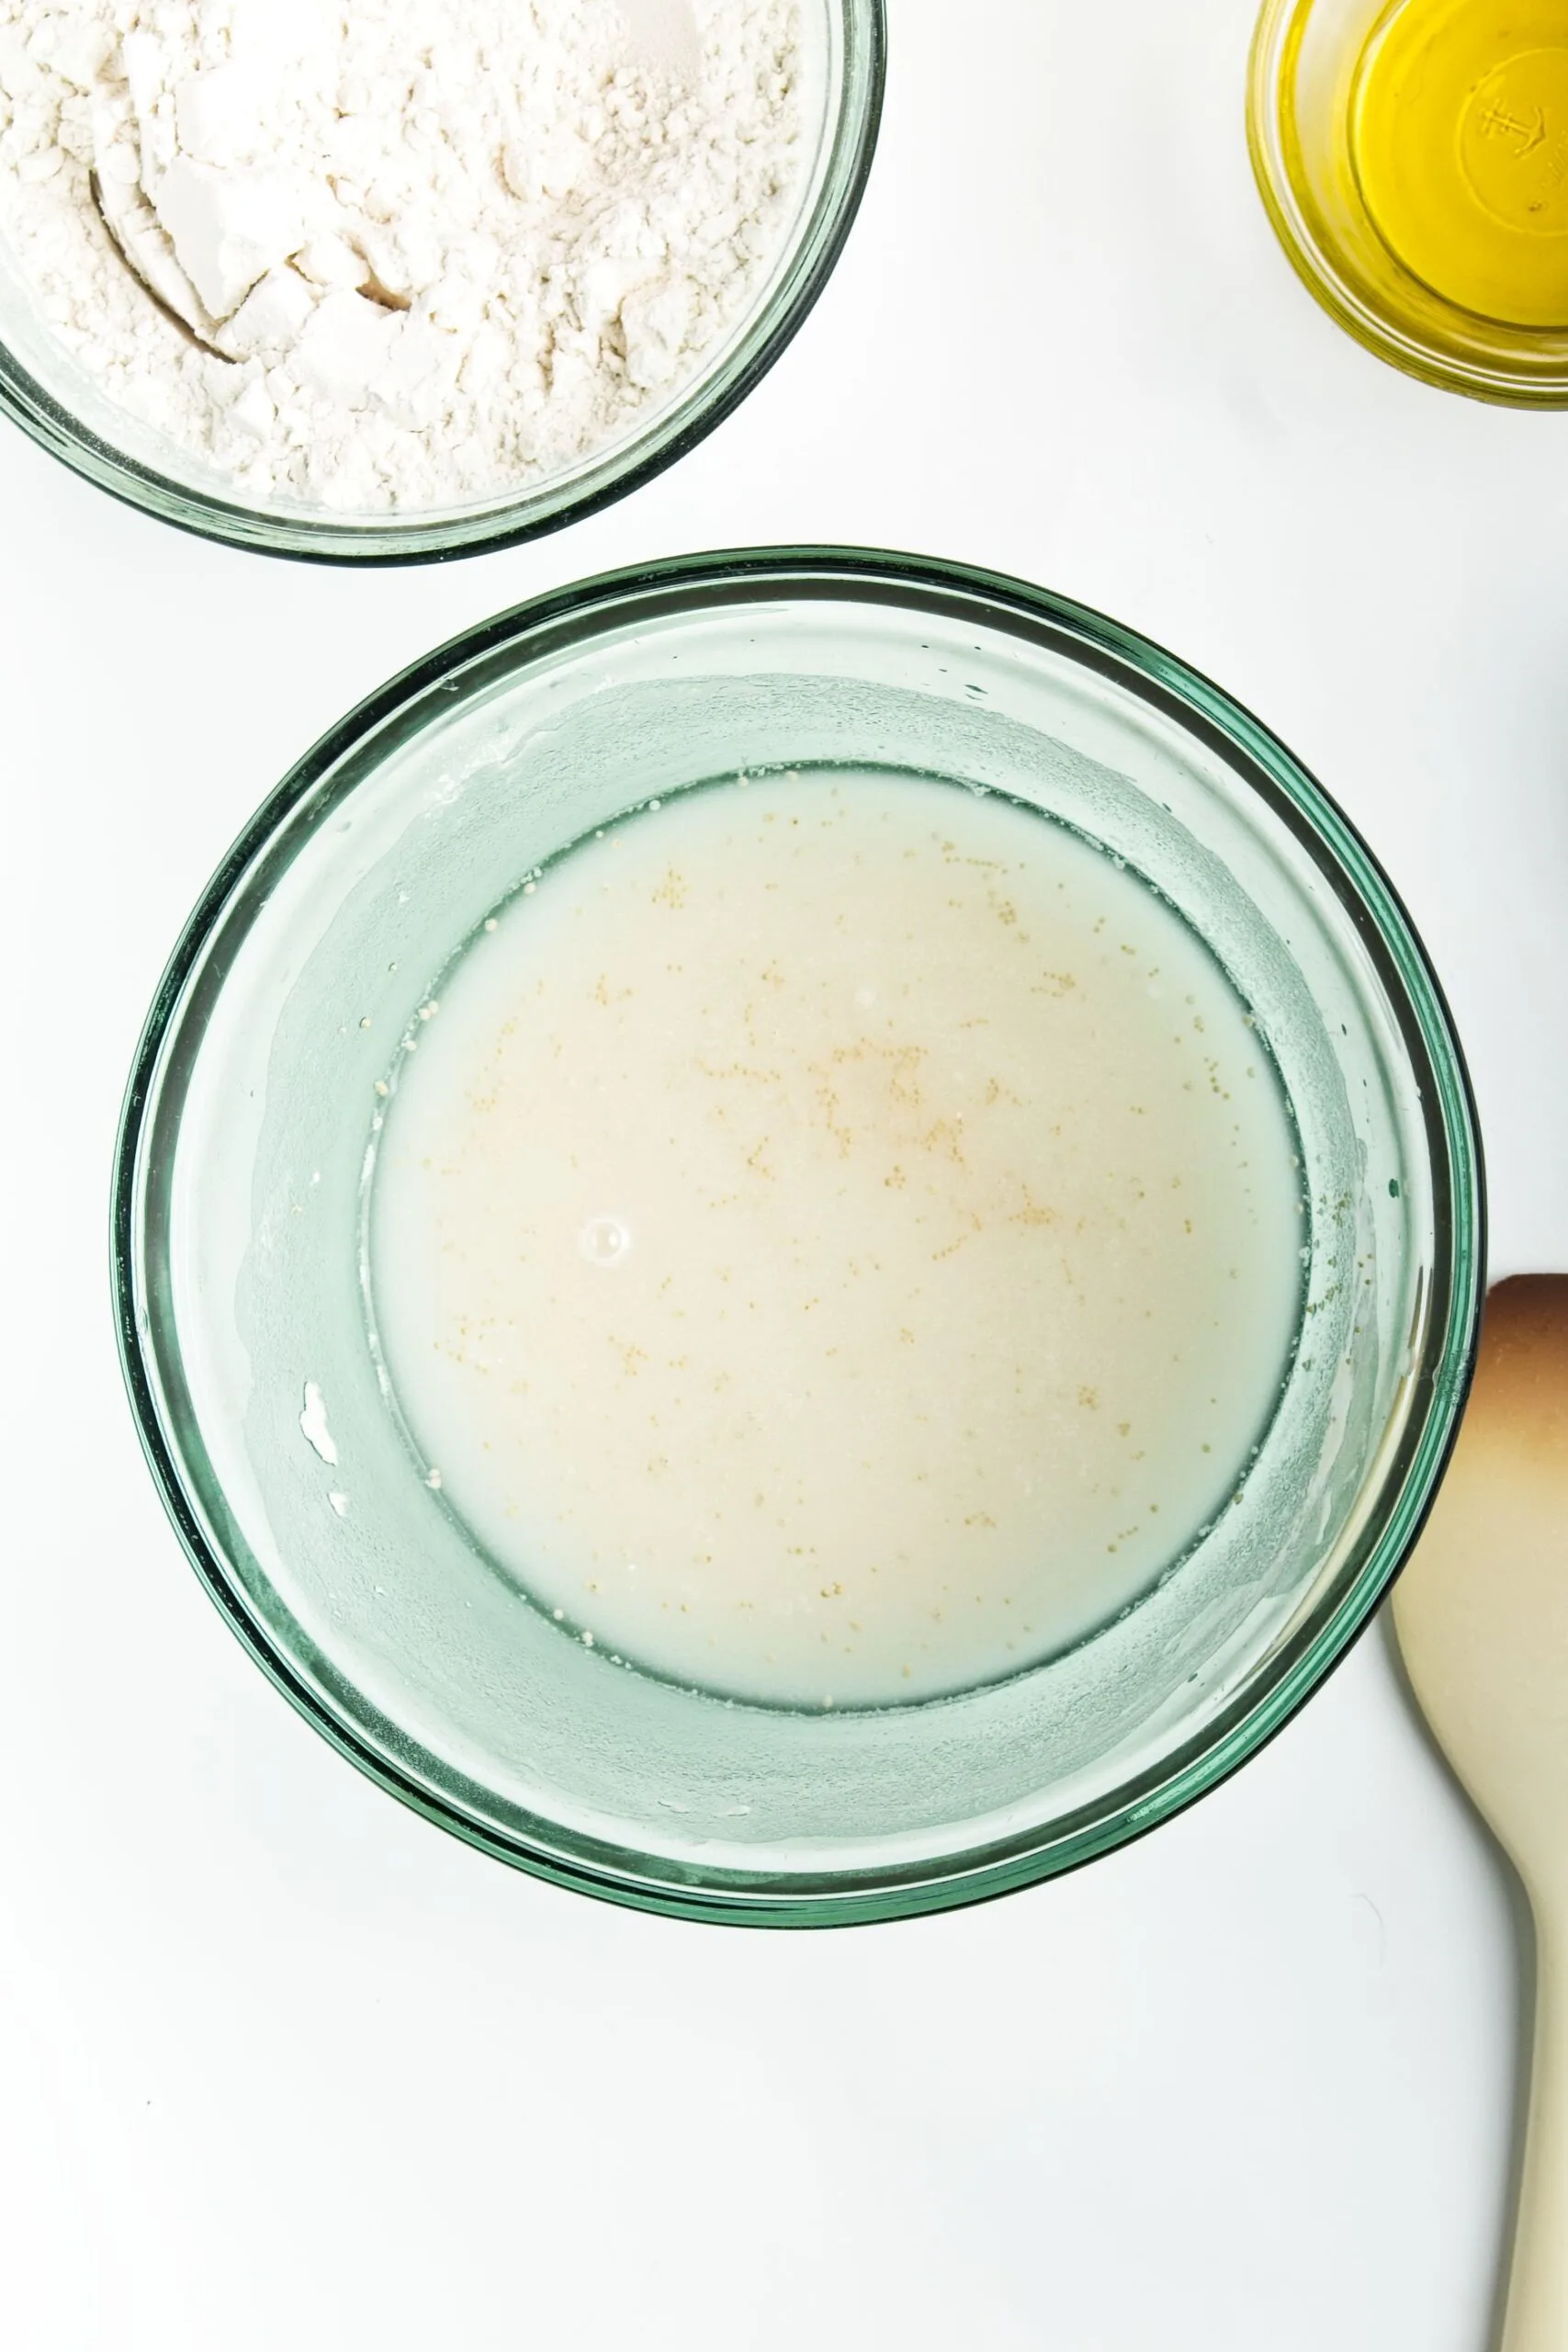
[{"x1": 1246, "y1": 0, "x2": 1568, "y2": 409}]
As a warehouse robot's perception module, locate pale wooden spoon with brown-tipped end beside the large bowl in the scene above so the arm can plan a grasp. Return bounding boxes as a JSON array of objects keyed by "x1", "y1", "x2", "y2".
[{"x1": 1394, "y1": 1275, "x2": 1568, "y2": 2352}]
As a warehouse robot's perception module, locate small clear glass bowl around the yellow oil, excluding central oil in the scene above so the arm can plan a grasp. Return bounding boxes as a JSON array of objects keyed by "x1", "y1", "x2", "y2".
[{"x1": 1246, "y1": 0, "x2": 1568, "y2": 409}]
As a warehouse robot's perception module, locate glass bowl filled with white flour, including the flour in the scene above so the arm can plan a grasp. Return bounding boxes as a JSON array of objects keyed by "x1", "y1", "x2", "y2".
[{"x1": 0, "y1": 0, "x2": 884, "y2": 562}]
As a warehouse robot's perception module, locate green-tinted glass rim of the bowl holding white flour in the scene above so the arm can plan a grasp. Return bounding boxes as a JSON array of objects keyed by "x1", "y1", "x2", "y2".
[{"x1": 0, "y1": 0, "x2": 888, "y2": 570}]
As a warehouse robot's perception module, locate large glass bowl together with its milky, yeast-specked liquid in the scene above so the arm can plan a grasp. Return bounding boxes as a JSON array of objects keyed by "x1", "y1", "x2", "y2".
[{"x1": 115, "y1": 550, "x2": 1483, "y2": 1924}]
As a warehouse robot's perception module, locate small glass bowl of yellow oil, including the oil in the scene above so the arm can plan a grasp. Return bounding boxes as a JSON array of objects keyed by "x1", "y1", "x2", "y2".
[{"x1": 1248, "y1": 0, "x2": 1568, "y2": 407}]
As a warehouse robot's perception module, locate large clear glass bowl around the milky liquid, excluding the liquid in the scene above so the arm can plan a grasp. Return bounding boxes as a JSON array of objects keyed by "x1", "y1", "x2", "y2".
[{"x1": 115, "y1": 550, "x2": 1483, "y2": 1924}]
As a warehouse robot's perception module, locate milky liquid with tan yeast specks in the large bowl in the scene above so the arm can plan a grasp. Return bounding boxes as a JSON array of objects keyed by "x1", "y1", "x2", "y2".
[{"x1": 369, "y1": 772, "x2": 1304, "y2": 1708}]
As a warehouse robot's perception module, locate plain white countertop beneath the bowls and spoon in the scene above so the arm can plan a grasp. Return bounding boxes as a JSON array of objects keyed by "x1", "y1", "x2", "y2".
[{"x1": 0, "y1": 0, "x2": 1568, "y2": 2352}]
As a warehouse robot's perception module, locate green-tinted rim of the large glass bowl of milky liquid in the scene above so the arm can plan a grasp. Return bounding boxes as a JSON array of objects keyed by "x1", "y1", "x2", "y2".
[{"x1": 113, "y1": 548, "x2": 1485, "y2": 1927}]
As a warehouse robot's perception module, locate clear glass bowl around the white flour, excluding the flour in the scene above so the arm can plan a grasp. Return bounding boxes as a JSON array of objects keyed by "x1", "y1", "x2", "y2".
[{"x1": 0, "y1": 0, "x2": 886, "y2": 564}]
